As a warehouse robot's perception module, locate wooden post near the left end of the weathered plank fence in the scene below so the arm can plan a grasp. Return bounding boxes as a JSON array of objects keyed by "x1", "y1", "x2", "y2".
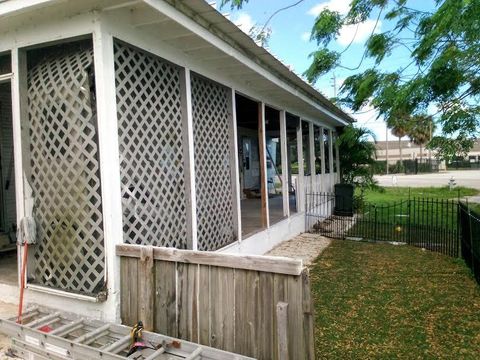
[{"x1": 138, "y1": 245, "x2": 155, "y2": 331}]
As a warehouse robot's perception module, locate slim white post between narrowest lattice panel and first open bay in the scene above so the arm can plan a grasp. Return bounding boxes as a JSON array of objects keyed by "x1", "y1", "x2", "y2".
[{"x1": 230, "y1": 89, "x2": 242, "y2": 242}]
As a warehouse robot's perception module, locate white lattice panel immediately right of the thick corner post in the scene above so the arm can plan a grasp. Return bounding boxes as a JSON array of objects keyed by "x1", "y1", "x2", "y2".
[{"x1": 115, "y1": 43, "x2": 187, "y2": 248}]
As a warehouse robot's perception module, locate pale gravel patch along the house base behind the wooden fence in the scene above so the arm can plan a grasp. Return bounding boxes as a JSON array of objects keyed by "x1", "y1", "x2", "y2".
[{"x1": 265, "y1": 233, "x2": 331, "y2": 266}]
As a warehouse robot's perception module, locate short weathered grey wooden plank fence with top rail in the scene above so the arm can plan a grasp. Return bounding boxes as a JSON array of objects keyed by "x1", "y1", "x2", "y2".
[{"x1": 117, "y1": 245, "x2": 315, "y2": 359}]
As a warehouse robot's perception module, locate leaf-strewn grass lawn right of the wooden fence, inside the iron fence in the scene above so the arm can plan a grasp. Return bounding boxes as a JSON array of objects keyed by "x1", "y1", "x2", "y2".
[{"x1": 310, "y1": 240, "x2": 480, "y2": 359}]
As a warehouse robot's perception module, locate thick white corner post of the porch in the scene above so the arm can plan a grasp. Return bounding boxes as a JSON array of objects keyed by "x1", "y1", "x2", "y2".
[{"x1": 93, "y1": 18, "x2": 123, "y2": 320}]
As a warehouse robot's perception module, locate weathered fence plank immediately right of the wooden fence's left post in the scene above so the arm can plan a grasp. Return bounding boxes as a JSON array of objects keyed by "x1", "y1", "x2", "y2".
[{"x1": 155, "y1": 258, "x2": 178, "y2": 337}]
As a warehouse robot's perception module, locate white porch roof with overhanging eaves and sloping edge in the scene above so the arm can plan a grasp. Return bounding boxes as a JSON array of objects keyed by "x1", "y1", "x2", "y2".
[{"x1": 0, "y1": 0, "x2": 354, "y2": 127}]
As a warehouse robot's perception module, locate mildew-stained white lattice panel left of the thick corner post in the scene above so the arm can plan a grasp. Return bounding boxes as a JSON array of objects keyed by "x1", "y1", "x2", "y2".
[{"x1": 28, "y1": 44, "x2": 105, "y2": 294}]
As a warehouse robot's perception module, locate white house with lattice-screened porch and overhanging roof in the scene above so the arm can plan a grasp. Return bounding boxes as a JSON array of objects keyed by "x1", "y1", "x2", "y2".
[{"x1": 0, "y1": 0, "x2": 352, "y2": 321}]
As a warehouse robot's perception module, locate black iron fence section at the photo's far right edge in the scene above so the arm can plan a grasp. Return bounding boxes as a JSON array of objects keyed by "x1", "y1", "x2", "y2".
[{"x1": 459, "y1": 203, "x2": 480, "y2": 284}]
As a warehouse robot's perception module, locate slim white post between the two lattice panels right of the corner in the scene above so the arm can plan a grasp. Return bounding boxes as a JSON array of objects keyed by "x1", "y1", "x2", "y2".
[{"x1": 181, "y1": 69, "x2": 198, "y2": 250}]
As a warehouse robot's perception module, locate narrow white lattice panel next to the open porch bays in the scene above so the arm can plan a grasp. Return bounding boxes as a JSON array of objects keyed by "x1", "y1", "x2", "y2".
[{"x1": 192, "y1": 76, "x2": 235, "y2": 250}]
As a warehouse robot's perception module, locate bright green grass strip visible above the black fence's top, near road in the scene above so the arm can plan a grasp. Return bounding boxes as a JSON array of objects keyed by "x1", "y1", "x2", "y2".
[{"x1": 357, "y1": 186, "x2": 479, "y2": 204}]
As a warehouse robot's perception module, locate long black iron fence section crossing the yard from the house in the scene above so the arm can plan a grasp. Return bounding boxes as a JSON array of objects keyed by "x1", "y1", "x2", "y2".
[{"x1": 306, "y1": 193, "x2": 459, "y2": 256}]
